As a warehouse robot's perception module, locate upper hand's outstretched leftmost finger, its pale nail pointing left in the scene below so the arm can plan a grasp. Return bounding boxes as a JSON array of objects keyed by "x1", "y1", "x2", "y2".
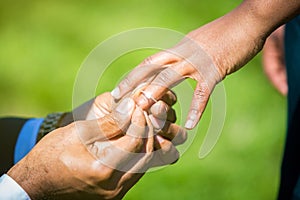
[{"x1": 111, "y1": 52, "x2": 174, "y2": 99}]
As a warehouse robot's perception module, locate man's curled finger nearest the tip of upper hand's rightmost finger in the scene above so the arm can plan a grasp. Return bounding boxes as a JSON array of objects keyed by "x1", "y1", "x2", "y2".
[{"x1": 157, "y1": 121, "x2": 187, "y2": 145}]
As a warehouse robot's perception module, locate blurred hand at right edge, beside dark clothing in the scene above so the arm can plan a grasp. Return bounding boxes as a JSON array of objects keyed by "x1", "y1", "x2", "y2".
[{"x1": 262, "y1": 26, "x2": 288, "y2": 96}]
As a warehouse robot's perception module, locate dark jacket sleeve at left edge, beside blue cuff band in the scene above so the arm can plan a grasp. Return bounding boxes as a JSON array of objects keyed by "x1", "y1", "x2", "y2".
[{"x1": 0, "y1": 118, "x2": 27, "y2": 175}]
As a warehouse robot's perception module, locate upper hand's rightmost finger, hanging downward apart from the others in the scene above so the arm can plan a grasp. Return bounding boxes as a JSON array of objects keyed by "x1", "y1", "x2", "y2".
[{"x1": 185, "y1": 82, "x2": 211, "y2": 129}]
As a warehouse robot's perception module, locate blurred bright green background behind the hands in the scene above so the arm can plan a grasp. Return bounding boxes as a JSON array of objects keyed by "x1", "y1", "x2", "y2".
[{"x1": 0, "y1": 0, "x2": 286, "y2": 200}]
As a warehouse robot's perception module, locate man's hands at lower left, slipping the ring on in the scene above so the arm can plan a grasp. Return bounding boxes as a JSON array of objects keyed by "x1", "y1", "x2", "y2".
[{"x1": 8, "y1": 93, "x2": 186, "y2": 199}]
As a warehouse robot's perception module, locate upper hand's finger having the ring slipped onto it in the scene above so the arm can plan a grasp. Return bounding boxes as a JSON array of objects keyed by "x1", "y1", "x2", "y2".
[{"x1": 136, "y1": 67, "x2": 185, "y2": 109}]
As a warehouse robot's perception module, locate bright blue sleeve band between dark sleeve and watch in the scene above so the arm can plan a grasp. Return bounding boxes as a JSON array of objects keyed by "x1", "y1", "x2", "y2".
[{"x1": 14, "y1": 118, "x2": 44, "y2": 164}]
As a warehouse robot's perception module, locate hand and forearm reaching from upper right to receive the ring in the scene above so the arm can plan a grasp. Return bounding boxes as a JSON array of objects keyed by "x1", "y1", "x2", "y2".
[{"x1": 112, "y1": 0, "x2": 300, "y2": 129}]
